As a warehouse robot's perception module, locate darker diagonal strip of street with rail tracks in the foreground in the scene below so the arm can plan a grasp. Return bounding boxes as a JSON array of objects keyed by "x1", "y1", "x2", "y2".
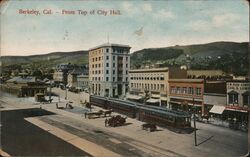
[{"x1": 39, "y1": 115, "x2": 184, "y2": 157}]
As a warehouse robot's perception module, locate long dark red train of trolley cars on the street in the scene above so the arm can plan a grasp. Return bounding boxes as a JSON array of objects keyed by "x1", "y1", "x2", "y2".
[{"x1": 90, "y1": 95, "x2": 191, "y2": 128}]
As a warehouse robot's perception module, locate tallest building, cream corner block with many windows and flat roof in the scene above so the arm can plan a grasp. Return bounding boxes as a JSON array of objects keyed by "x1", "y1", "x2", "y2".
[{"x1": 89, "y1": 43, "x2": 131, "y2": 97}]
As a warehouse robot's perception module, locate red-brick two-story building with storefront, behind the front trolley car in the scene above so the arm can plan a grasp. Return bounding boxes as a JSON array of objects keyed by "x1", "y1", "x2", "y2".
[{"x1": 168, "y1": 79, "x2": 204, "y2": 114}]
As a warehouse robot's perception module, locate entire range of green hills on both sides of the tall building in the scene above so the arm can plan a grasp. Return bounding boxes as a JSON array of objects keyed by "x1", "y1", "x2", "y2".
[{"x1": 1, "y1": 41, "x2": 249, "y2": 75}]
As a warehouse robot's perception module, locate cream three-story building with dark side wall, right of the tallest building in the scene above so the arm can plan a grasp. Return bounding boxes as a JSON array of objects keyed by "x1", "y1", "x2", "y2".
[{"x1": 128, "y1": 68, "x2": 187, "y2": 103}]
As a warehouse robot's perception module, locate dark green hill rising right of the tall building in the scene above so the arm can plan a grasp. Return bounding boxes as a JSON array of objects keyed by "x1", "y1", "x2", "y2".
[{"x1": 131, "y1": 42, "x2": 249, "y2": 75}]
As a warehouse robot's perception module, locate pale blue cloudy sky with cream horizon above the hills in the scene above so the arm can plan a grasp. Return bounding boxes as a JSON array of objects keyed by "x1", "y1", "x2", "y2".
[{"x1": 0, "y1": 0, "x2": 249, "y2": 56}]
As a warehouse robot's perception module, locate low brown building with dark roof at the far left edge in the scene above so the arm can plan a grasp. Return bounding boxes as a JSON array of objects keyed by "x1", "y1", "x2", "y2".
[{"x1": 1, "y1": 76, "x2": 47, "y2": 97}]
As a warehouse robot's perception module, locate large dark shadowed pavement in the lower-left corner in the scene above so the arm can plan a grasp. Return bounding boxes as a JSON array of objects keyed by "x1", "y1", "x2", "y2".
[{"x1": 1, "y1": 109, "x2": 91, "y2": 156}]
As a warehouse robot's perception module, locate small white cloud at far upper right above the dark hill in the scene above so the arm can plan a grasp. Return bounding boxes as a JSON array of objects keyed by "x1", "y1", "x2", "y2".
[{"x1": 212, "y1": 13, "x2": 239, "y2": 27}]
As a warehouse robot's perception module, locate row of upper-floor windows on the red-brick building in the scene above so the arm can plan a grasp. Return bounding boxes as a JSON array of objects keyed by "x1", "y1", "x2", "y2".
[{"x1": 170, "y1": 86, "x2": 201, "y2": 95}]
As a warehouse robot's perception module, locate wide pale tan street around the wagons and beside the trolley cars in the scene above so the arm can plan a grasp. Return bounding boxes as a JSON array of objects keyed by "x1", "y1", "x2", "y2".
[{"x1": 1, "y1": 89, "x2": 248, "y2": 157}]
